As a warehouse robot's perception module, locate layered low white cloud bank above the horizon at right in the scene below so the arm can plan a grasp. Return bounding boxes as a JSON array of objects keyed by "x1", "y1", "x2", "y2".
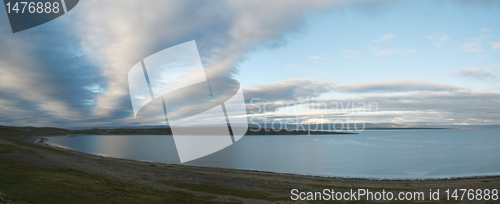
[{"x1": 245, "y1": 80, "x2": 500, "y2": 125}]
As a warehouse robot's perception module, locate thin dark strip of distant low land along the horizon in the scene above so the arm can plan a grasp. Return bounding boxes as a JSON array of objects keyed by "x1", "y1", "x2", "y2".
[{"x1": 0, "y1": 123, "x2": 500, "y2": 136}]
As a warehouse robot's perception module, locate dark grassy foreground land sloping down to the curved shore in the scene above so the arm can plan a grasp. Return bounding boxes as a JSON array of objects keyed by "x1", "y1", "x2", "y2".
[{"x1": 0, "y1": 127, "x2": 500, "y2": 204}]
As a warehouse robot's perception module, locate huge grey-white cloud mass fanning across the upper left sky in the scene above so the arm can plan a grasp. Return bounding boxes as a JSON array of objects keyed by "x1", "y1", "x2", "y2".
[{"x1": 0, "y1": 0, "x2": 348, "y2": 127}]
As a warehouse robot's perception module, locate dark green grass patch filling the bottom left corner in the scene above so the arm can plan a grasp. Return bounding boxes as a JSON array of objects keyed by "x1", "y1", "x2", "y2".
[{"x1": 0, "y1": 159, "x2": 236, "y2": 204}]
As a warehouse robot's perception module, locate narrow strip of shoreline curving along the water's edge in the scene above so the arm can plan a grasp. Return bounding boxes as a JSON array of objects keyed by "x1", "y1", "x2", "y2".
[{"x1": 39, "y1": 134, "x2": 500, "y2": 182}]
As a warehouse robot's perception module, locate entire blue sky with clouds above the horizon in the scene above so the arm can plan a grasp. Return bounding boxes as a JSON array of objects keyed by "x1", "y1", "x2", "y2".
[{"x1": 0, "y1": 0, "x2": 500, "y2": 127}]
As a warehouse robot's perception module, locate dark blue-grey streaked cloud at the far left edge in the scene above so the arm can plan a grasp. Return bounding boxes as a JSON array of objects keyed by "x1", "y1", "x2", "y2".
[{"x1": 0, "y1": 13, "x2": 108, "y2": 126}]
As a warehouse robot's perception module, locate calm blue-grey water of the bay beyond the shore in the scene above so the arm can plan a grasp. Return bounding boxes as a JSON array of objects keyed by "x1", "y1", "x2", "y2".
[{"x1": 46, "y1": 130, "x2": 500, "y2": 178}]
